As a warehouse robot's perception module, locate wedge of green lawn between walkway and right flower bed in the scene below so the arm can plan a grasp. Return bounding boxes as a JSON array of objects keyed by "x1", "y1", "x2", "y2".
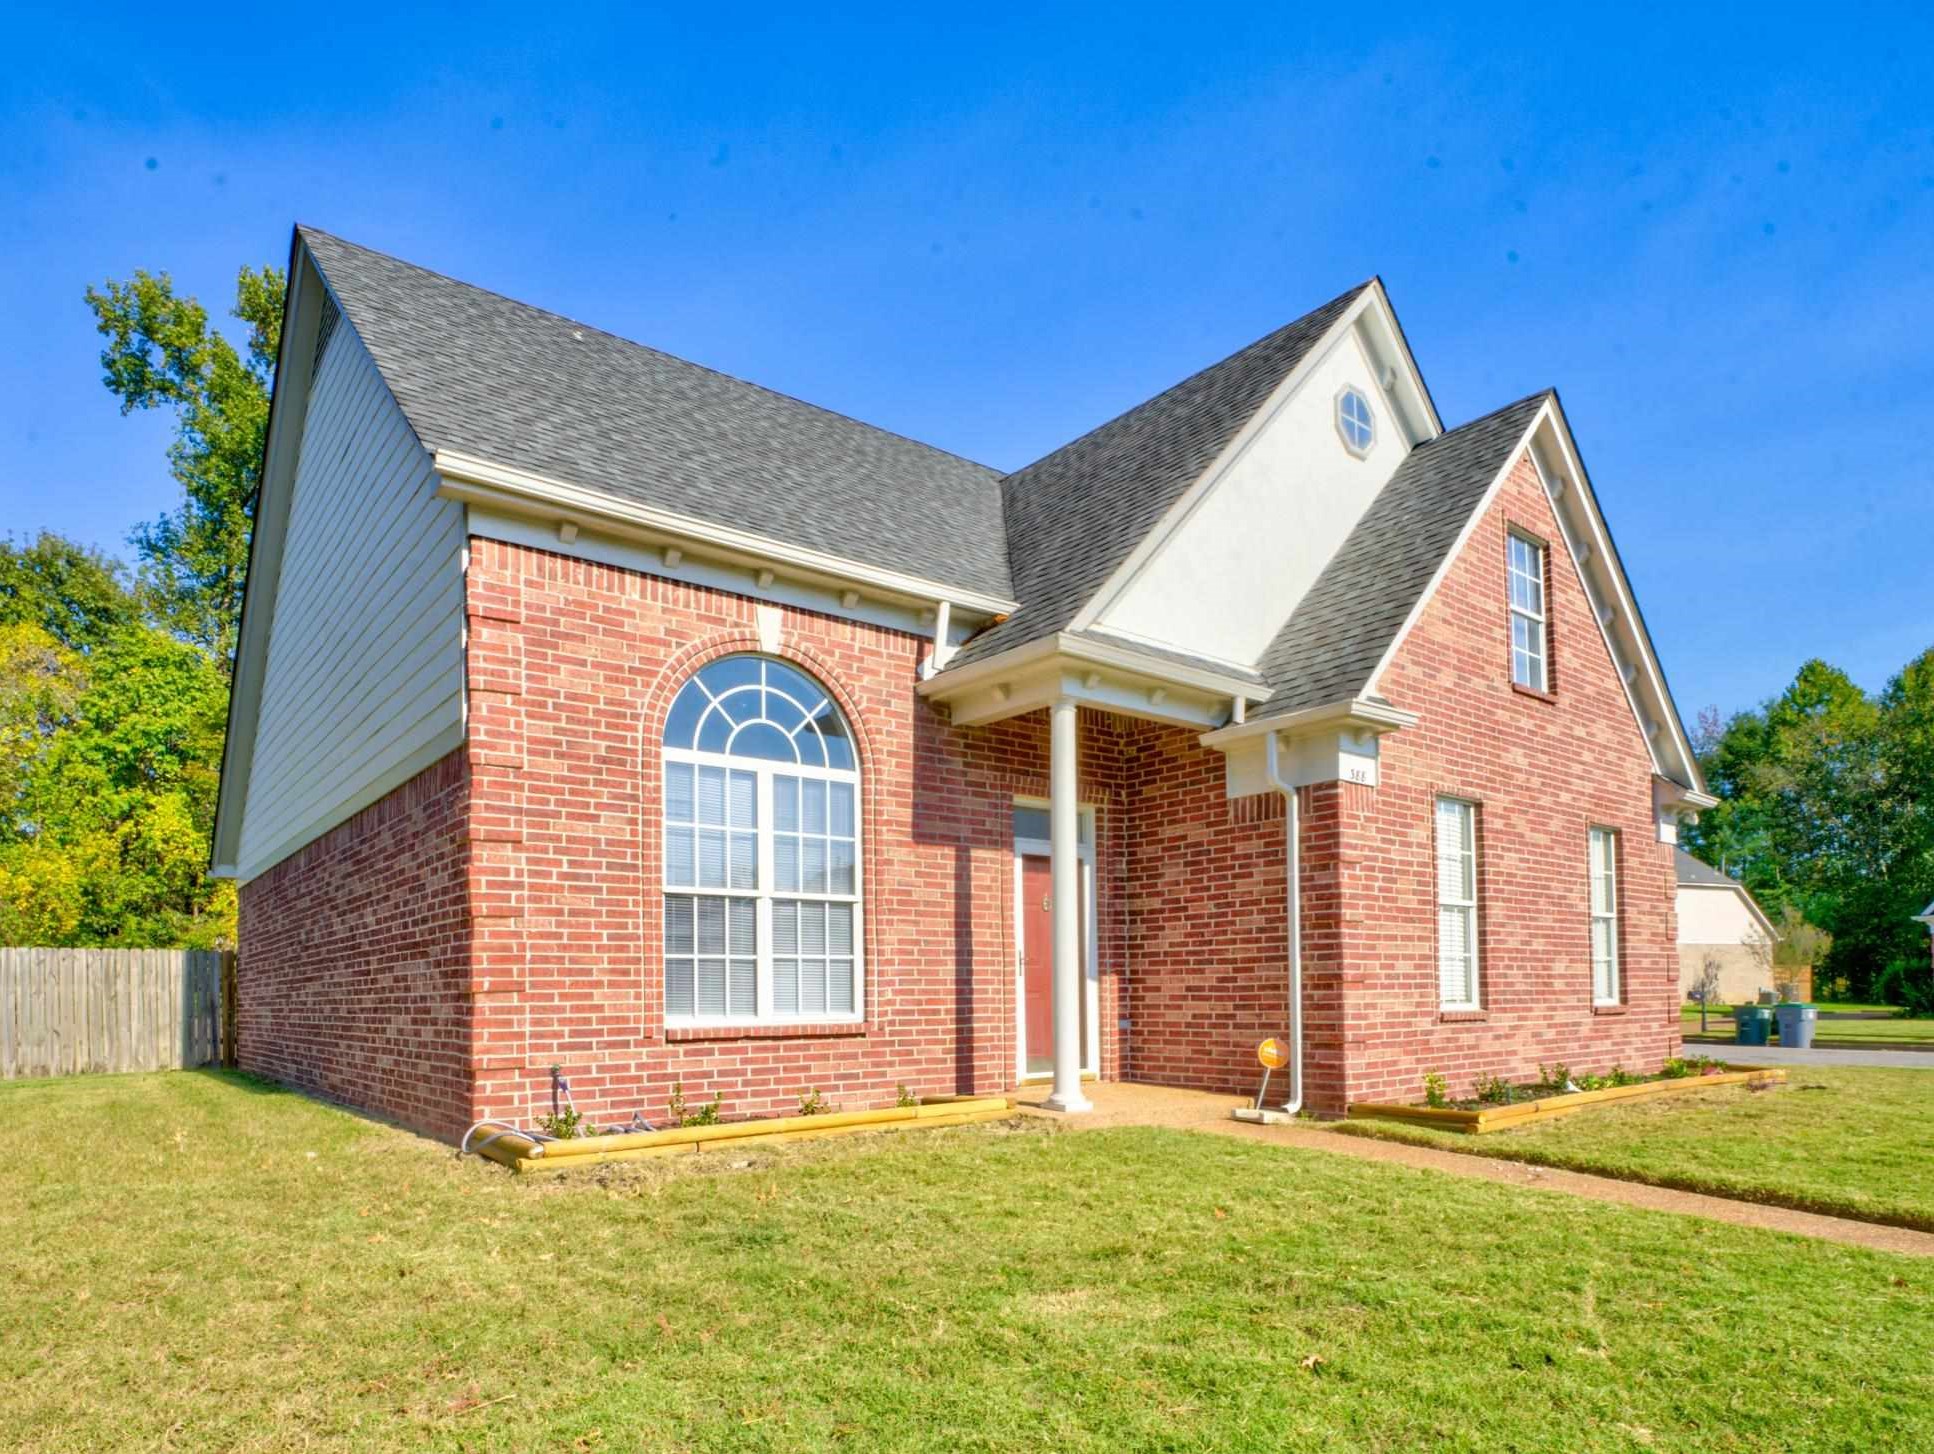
[{"x1": 1338, "y1": 1061, "x2": 1934, "y2": 1232}]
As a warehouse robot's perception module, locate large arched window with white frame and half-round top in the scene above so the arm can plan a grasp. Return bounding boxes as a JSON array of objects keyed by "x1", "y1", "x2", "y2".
[{"x1": 665, "y1": 655, "x2": 861, "y2": 1025}]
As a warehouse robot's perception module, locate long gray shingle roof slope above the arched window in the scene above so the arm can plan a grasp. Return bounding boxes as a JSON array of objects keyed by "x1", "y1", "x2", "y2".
[{"x1": 300, "y1": 228, "x2": 1011, "y2": 599}]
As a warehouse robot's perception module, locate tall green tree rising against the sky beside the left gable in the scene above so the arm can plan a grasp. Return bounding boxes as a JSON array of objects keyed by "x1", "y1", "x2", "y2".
[{"x1": 87, "y1": 267, "x2": 284, "y2": 677}]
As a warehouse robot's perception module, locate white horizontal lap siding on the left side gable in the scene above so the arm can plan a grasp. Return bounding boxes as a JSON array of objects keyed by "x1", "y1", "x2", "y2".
[{"x1": 238, "y1": 319, "x2": 464, "y2": 880}]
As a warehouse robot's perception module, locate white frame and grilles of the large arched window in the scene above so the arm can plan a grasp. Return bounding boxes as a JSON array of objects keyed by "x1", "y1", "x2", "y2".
[{"x1": 658, "y1": 654, "x2": 866, "y2": 1031}]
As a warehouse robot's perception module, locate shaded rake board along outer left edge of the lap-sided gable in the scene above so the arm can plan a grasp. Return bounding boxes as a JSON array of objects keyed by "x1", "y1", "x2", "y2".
[{"x1": 209, "y1": 234, "x2": 328, "y2": 878}]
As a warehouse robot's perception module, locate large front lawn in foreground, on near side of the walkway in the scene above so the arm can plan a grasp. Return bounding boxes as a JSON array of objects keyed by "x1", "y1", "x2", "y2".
[{"x1": 0, "y1": 1073, "x2": 1934, "y2": 1452}]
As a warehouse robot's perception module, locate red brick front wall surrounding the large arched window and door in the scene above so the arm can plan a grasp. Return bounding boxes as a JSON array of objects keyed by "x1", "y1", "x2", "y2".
[{"x1": 468, "y1": 539, "x2": 1124, "y2": 1120}]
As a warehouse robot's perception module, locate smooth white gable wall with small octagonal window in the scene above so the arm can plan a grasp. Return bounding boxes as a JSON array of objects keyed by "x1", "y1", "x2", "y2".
[{"x1": 1097, "y1": 331, "x2": 1410, "y2": 663}]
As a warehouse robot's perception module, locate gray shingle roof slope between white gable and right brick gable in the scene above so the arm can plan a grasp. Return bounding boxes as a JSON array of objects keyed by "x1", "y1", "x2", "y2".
[{"x1": 1249, "y1": 393, "x2": 1549, "y2": 721}]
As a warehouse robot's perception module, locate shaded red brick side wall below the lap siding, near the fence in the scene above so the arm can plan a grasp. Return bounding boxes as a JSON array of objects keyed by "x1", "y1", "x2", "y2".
[{"x1": 236, "y1": 752, "x2": 470, "y2": 1139}]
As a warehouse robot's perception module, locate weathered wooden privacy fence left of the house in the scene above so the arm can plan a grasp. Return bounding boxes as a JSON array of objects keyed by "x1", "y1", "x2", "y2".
[{"x1": 0, "y1": 949, "x2": 234, "y2": 1079}]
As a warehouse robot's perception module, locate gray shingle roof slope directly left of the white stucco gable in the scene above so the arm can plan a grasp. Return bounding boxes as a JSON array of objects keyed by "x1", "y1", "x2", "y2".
[{"x1": 950, "y1": 282, "x2": 1369, "y2": 669}]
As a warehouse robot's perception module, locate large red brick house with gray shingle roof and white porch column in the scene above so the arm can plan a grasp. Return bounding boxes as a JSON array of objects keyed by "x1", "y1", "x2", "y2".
[{"x1": 215, "y1": 230, "x2": 1712, "y2": 1135}]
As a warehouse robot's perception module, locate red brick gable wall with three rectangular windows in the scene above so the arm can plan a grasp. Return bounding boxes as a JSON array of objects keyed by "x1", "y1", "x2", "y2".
[{"x1": 1305, "y1": 448, "x2": 1679, "y2": 1112}]
